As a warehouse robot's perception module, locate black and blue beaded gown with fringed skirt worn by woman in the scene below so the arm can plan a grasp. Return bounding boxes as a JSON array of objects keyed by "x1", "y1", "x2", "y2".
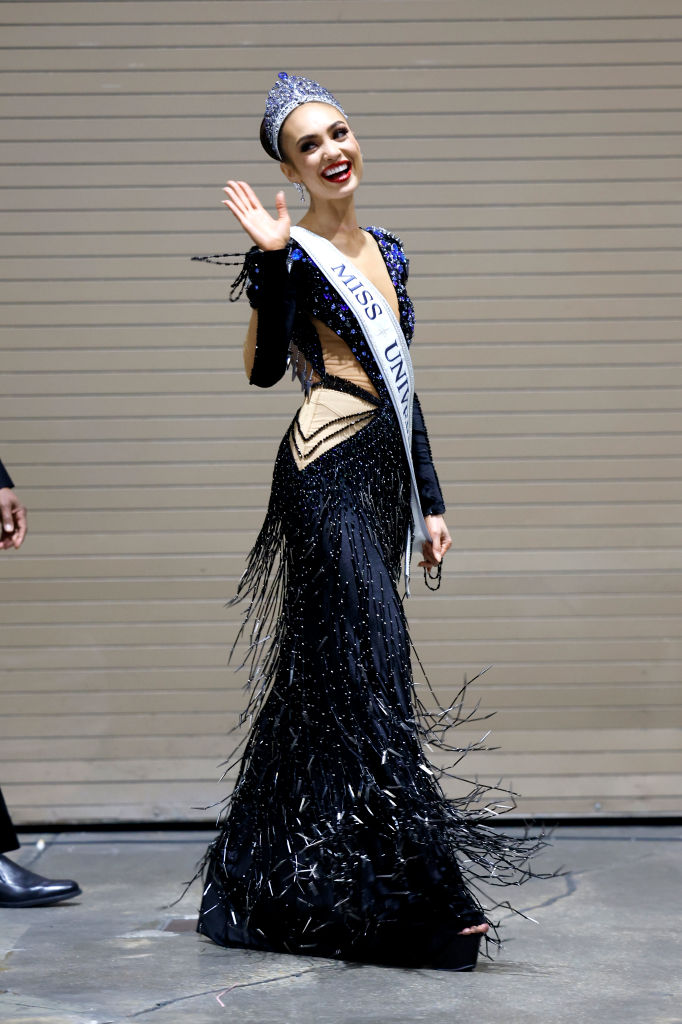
[{"x1": 198, "y1": 227, "x2": 544, "y2": 967}]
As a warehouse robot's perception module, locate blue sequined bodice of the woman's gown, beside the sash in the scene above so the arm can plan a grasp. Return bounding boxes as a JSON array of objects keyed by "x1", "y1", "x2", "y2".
[{"x1": 290, "y1": 226, "x2": 415, "y2": 394}]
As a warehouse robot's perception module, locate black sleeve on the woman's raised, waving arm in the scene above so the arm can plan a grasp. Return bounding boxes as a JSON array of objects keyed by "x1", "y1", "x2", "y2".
[{"x1": 246, "y1": 246, "x2": 296, "y2": 387}]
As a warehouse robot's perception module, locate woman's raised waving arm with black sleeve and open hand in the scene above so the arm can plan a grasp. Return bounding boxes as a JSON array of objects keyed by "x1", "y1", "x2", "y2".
[{"x1": 223, "y1": 180, "x2": 296, "y2": 387}]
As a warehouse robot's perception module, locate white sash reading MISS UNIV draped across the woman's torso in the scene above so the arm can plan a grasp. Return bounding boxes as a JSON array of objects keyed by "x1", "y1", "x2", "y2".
[{"x1": 291, "y1": 226, "x2": 431, "y2": 596}]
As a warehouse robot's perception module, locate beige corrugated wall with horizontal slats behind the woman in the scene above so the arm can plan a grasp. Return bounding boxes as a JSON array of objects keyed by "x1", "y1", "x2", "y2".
[{"x1": 0, "y1": 0, "x2": 682, "y2": 822}]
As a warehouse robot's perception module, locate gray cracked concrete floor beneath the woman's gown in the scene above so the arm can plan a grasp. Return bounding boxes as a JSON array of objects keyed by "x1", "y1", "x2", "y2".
[{"x1": 0, "y1": 826, "x2": 682, "y2": 1024}]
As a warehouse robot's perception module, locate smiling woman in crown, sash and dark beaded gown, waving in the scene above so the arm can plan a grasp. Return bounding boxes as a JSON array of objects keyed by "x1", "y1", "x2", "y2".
[{"x1": 199, "y1": 73, "x2": 543, "y2": 970}]
